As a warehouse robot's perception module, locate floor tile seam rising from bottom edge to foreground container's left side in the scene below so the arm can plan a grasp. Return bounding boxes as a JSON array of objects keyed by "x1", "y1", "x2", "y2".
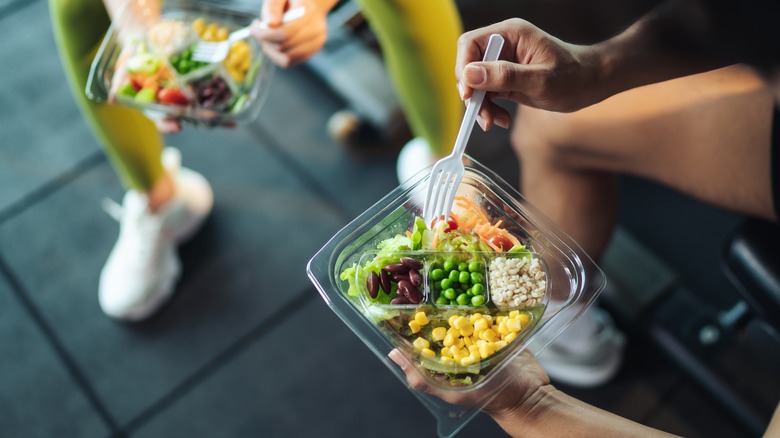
[{"x1": 119, "y1": 287, "x2": 319, "y2": 434}]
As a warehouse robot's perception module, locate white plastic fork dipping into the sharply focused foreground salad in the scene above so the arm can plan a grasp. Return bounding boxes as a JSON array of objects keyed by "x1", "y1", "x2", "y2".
[{"x1": 423, "y1": 34, "x2": 504, "y2": 225}]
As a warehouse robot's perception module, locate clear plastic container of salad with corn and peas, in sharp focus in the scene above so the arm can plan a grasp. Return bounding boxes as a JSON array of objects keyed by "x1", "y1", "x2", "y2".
[{"x1": 307, "y1": 155, "x2": 605, "y2": 436}]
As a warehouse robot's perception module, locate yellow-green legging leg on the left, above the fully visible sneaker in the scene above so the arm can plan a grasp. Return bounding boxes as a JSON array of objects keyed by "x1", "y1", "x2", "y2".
[{"x1": 49, "y1": 0, "x2": 164, "y2": 192}]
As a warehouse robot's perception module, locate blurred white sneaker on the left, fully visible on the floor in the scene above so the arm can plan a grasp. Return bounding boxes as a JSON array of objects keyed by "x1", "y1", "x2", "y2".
[{"x1": 98, "y1": 148, "x2": 214, "y2": 321}]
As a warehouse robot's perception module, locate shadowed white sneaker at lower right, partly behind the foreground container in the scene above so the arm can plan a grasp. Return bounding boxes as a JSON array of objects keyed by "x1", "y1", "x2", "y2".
[{"x1": 535, "y1": 307, "x2": 626, "y2": 388}]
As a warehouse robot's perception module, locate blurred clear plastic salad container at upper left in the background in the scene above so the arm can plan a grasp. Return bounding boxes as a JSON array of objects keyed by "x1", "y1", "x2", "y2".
[{"x1": 86, "y1": 0, "x2": 274, "y2": 127}]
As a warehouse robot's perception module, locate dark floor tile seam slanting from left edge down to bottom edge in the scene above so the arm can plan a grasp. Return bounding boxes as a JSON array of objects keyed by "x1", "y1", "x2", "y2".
[{"x1": 0, "y1": 251, "x2": 118, "y2": 433}]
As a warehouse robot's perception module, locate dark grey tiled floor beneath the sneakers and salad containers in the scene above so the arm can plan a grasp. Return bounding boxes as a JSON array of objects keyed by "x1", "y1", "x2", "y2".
[{"x1": 0, "y1": 0, "x2": 776, "y2": 437}]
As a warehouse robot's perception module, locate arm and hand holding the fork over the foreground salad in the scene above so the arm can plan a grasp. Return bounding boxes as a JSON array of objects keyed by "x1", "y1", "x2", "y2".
[{"x1": 455, "y1": 0, "x2": 730, "y2": 129}]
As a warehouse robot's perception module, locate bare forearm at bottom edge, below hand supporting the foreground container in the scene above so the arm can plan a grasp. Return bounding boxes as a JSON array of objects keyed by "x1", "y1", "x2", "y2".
[{"x1": 491, "y1": 385, "x2": 673, "y2": 438}]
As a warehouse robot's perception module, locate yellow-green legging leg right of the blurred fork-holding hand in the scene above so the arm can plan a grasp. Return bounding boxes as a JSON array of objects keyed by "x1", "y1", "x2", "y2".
[{"x1": 357, "y1": 0, "x2": 464, "y2": 156}]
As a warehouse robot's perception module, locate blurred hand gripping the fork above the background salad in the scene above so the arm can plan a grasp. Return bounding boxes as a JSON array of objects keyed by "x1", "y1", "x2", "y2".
[{"x1": 251, "y1": 0, "x2": 336, "y2": 68}]
